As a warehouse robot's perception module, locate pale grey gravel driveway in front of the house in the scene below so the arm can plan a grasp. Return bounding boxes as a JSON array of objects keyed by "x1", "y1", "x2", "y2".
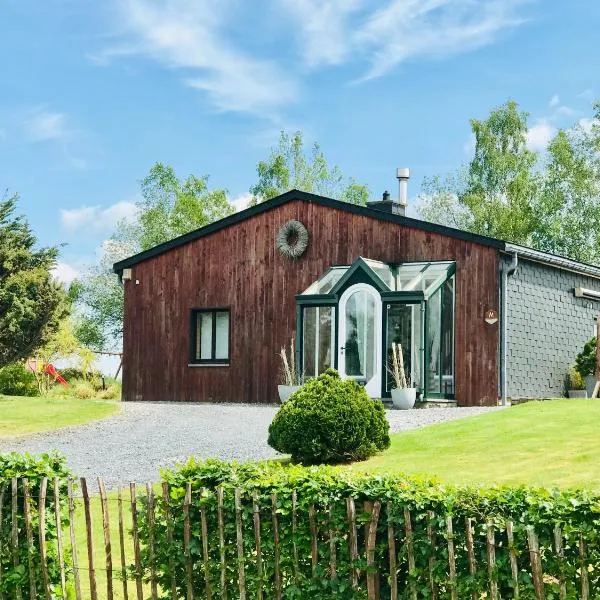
[{"x1": 0, "y1": 402, "x2": 495, "y2": 487}]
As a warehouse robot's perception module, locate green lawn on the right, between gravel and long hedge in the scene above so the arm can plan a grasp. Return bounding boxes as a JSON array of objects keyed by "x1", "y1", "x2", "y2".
[{"x1": 350, "y1": 400, "x2": 600, "y2": 489}]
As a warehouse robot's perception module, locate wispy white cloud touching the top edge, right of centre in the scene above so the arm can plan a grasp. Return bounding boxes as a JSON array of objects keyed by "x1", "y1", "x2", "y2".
[{"x1": 355, "y1": 0, "x2": 524, "y2": 79}]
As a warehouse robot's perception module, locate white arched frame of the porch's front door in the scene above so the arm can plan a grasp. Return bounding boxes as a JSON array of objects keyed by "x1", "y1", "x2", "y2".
[{"x1": 338, "y1": 283, "x2": 383, "y2": 398}]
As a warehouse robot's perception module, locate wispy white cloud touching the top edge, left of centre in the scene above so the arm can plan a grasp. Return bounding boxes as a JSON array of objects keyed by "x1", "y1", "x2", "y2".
[{"x1": 101, "y1": 0, "x2": 297, "y2": 114}]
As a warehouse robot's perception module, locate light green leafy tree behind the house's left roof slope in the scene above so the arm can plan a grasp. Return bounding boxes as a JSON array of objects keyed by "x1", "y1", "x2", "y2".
[{"x1": 71, "y1": 163, "x2": 234, "y2": 350}]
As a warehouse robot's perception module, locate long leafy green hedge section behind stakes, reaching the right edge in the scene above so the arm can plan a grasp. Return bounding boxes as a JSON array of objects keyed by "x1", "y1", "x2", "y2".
[{"x1": 139, "y1": 460, "x2": 600, "y2": 600}]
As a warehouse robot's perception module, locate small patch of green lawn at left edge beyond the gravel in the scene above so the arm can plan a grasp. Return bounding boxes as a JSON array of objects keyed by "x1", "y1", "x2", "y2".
[{"x1": 0, "y1": 396, "x2": 120, "y2": 437}]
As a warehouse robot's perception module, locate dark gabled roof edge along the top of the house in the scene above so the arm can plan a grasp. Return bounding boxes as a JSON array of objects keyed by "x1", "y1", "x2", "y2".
[{"x1": 113, "y1": 190, "x2": 600, "y2": 279}]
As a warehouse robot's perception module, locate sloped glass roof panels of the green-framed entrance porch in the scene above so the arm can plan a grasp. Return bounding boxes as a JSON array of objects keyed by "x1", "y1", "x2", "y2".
[{"x1": 302, "y1": 257, "x2": 455, "y2": 297}]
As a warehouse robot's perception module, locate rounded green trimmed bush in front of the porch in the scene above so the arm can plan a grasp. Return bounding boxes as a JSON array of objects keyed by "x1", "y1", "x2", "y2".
[{"x1": 269, "y1": 369, "x2": 390, "y2": 464}]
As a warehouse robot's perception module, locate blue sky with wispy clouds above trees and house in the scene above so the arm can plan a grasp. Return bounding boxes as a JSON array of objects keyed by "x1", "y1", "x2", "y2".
[{"x1": 0, "y1": 0, "x2": 600, "y2": 279}]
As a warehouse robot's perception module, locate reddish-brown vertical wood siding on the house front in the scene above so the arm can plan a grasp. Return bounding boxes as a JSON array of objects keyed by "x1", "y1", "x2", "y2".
[{"x1": 123, "y1": 200, "x2": 499, "y2": 406}]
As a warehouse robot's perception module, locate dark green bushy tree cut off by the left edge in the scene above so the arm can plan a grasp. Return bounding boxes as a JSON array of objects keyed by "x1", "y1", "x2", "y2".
[{"x1": 0, "y1": 195, "x2": 68, "y2": 367}]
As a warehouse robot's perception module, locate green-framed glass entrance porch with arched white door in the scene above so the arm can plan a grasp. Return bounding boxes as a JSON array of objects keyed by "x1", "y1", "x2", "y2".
[{"x1": 296, "y1": 258, "x2": 455, "y2": 399}]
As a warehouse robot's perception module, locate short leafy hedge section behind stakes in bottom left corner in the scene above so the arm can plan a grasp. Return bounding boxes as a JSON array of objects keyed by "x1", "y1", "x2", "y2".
[{"x1": 0, "y1": 452, "x2": 70, "y2": 600}]
